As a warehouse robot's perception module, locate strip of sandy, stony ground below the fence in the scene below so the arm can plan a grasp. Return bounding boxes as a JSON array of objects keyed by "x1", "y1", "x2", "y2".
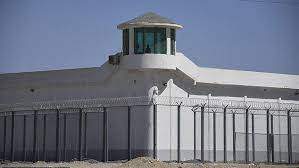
[{"x1": 0, "y1": 157, "x2": 299, "y2": 168}]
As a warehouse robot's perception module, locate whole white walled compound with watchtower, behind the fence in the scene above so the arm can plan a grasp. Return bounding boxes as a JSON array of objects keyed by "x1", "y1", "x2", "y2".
[{"x1": 0, "y1": 13, "x2": 299, "y2": 161}]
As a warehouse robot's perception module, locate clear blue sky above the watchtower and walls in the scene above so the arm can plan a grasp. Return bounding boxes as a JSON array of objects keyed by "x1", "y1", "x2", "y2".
[{"x1": 0, "y1": 0, "x2": 299, "y2": 75}]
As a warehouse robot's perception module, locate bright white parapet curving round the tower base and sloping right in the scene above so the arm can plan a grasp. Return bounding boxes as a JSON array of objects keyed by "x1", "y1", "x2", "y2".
[{"x1": 121, "y1": 51, "x2": 299, "y2": 89}]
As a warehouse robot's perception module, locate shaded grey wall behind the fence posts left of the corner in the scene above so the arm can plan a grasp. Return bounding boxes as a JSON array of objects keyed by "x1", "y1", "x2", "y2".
[{"x1": 0, "y1": 106, "x2": 153, "y2": 161}]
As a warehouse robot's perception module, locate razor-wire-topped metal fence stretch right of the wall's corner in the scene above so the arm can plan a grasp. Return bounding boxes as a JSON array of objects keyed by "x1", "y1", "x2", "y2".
[{"x1": 156, "y1": 96, "x2": 299, "y2": 163}]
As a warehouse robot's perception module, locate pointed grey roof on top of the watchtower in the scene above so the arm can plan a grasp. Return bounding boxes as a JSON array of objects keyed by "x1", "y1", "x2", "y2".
[{"x1": 117, "y1": 12, "x2": 183, "y2": 29}]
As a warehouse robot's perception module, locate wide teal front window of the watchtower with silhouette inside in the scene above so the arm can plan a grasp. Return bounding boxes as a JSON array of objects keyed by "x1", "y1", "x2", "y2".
[{"x1": 134, "y1": 27, "x2": 166, "y2": 54}]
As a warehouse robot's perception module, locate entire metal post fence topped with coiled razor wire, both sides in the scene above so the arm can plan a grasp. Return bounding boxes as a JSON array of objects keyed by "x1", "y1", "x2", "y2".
[{"x1": 0, "y1": 96, "x2": 299, "y2": 163}]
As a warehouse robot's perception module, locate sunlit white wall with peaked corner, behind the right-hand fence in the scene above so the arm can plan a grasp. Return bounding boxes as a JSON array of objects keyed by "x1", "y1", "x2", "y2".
[{"x1": 158, "y1": 81, "x2": 299, "y2": 162}]
